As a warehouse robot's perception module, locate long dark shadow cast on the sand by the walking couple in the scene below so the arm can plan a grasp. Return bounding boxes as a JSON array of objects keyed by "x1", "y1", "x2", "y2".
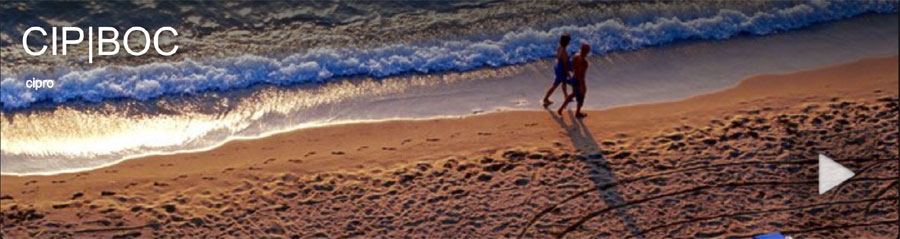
[{"x1": 547, "y1": 110, "x2": 641, "y2": 236}]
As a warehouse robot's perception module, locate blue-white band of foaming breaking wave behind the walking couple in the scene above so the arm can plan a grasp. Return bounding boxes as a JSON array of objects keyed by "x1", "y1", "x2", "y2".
[{"x1": 0, "y1": 0, "x2": 898, "y2": 110}]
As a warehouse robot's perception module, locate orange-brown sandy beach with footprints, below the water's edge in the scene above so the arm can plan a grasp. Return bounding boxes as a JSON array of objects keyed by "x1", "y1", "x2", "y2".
[{"x1": 0, "y1": 55, "x2": 900, "y2": 238}]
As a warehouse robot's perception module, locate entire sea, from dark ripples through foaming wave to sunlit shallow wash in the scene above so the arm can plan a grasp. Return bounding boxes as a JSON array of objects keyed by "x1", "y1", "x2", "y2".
[{"x1": 0, "y1": 1, "x2": 898, "y2": 174}]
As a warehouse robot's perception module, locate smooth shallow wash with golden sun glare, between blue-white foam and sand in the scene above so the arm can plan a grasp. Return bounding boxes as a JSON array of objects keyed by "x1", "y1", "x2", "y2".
[{"x1": 0, "y1": 12, "x2": 896, "y2": 176}]
